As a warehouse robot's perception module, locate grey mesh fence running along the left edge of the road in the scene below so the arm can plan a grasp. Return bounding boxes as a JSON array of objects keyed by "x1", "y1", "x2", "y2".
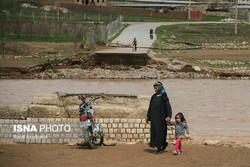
[{"x1": 84, "y1": 16, "x2": 123, "y2": 45}]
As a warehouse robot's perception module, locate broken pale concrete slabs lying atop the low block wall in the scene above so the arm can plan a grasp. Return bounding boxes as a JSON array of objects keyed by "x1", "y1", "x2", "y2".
[{"x1": 0, "y1": 94, "x2": 150, "y2": 119}]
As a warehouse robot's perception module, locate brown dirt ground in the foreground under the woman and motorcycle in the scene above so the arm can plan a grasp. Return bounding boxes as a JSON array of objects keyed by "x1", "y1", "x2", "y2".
[{"x1": 0, "y1": 144, "x2": 250, "y2": 167}]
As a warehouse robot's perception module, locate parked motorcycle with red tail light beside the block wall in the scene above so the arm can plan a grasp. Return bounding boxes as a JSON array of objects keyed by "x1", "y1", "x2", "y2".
[{"x1": 79, "y1": 96, "x2": 104, "y2": 149}]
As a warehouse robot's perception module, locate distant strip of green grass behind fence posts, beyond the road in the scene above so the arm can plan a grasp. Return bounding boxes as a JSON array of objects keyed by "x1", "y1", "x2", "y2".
[{"x1": 0, "y1": 9, "x2": 192, "y2": 24}]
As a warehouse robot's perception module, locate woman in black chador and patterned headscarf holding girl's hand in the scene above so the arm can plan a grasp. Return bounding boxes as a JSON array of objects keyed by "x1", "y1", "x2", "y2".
[{"x1": 146, "y1": 81, "x2": 172, "y2": 154}]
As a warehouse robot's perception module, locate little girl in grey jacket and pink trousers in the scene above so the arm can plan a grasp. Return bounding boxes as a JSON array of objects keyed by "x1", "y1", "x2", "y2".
[{"x1": 170, "y1": 112, "x2": 189, "y2": 155}]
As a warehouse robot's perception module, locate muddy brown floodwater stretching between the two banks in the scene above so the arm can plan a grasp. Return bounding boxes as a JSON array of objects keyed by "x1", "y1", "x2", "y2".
[{"x1": 0, "y1": 79, "x2": 250, "y2": 141}]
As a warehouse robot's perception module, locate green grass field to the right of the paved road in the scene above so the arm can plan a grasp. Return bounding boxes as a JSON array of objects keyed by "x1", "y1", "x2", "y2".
[{"x1": 153, "y1": 23, "x2": 250, "y2": 49}]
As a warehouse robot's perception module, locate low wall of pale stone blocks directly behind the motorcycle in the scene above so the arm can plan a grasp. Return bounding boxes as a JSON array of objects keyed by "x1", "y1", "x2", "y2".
[{"x1": 0, "y1": 118, "x2": 175, "y2": 143}]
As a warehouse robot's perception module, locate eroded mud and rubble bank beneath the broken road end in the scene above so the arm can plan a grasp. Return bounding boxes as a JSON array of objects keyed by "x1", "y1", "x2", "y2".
[{"x1": 0, "y1": 51, "x2": 250, "y2": 79}]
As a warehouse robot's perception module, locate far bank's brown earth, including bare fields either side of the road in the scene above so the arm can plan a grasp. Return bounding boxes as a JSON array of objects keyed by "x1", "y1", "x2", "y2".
[{"x1": 0, "y1": 42, "x2": 250, "y2": 79}]
